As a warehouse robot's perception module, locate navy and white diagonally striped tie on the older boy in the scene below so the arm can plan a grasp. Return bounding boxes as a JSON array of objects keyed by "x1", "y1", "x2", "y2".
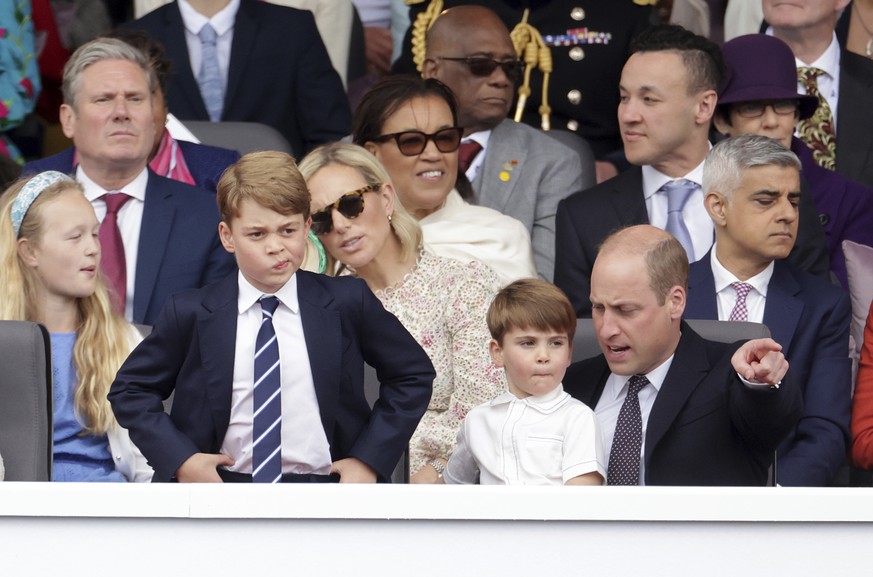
[{"x1": 252, "y1": 297, "x2": 282, "y2": 483}]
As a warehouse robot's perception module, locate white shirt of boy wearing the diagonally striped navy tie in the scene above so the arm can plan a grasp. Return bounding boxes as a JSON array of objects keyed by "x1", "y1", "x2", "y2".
[{"x1": 221, "y1": 272, "x2": 331, "y2": 475}]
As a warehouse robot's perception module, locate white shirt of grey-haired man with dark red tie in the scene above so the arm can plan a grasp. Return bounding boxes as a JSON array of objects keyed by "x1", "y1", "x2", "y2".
[{"x1": 76, "y1": 164, "x2": 149, "y2": 321}]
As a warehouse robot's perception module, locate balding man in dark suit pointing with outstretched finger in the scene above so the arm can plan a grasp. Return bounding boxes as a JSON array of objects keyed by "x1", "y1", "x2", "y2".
[{"x1": 564, "y1": 225, "x2": 801, "y2": 485}]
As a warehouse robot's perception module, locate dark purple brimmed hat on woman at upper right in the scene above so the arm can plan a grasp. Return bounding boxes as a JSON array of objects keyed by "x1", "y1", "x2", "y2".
[{"x1": 718, "y1": 34, "x2": 818, "y2": 120}]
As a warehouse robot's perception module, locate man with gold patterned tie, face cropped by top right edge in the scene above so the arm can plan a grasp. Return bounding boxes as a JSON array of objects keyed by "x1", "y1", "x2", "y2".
[{"x1": 763, "y1": 0, "x2": 873, "y2": 188}]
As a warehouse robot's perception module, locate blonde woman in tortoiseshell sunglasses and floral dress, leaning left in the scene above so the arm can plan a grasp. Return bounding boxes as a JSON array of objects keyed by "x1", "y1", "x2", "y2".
[{"x1": 300, "y1": 144, "x2": 506, "y2": 483}]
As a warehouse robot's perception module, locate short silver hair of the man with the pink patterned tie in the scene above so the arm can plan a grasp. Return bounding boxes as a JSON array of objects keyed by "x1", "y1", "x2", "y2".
[{"x1": 703, "y1": 134, "x2": 801, "y2": 200}]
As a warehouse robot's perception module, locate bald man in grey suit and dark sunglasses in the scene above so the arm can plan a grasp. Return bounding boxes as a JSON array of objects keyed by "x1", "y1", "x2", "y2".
[{"x1": 422, "y1": 6, "x2": 594, "y2": 281}]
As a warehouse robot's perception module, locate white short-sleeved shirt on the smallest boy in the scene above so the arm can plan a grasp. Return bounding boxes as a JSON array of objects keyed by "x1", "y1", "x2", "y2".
[{"x1": 443, "y1": 384, "x2": 606, "y2": 485}]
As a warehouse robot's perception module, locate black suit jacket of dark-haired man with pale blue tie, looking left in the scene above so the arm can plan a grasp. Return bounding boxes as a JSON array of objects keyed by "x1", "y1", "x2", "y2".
[{"x1": 555, "y1": 166, "x2": 830, "y2": 317}]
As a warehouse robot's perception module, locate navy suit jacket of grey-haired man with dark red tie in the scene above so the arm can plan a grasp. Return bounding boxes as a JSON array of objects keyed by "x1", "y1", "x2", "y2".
[{"x1": 25, "y1": 148, "x2": 236, "y2": 325}]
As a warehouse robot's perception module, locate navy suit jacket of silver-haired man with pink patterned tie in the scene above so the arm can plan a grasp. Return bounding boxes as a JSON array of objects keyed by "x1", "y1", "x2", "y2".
[{"x1": 685, "y1": 253, "x2": 852, "y2": 487}]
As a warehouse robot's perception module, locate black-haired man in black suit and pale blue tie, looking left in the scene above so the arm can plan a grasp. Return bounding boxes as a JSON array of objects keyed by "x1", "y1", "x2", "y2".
[{"x1": 555, "y1": 26, "x2": 829, "y2": 316}]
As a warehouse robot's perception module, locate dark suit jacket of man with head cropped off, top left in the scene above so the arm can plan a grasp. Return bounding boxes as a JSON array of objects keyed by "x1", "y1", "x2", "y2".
[{"x1": 126, "y1": 0, "x2": 351, "y2": 158}]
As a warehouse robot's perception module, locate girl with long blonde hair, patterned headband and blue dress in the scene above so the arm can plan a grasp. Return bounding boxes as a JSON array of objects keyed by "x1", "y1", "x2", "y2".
[{"x1": 0, "y1": 171, "x2": 152, "y2": 482}]
